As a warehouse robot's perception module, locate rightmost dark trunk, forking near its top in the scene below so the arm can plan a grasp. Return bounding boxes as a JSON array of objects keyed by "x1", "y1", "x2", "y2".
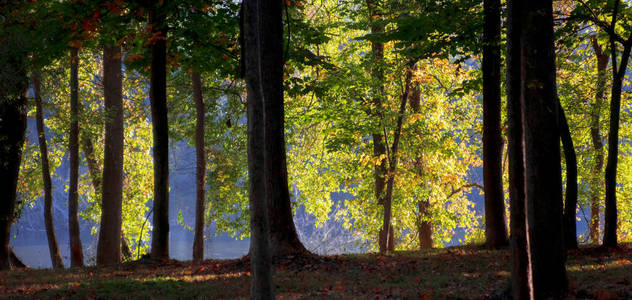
[{"x1": 603, "y1": 41, "x2": 632, "y2": 247}]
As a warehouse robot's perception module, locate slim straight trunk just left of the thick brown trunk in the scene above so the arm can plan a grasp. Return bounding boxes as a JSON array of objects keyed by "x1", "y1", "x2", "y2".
[{"x1": 68, "y1": 48, "x2": 83, "y2": 267}]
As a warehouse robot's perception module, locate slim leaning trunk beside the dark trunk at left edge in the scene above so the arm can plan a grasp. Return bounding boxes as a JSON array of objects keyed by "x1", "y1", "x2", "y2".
[{"x1": 33, "y1": 72, "x2": 64, "y2": 269}]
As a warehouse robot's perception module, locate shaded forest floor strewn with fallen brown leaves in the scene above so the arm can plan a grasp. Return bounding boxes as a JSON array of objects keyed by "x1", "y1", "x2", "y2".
[{"x1": 0, "y1": 244, "x2": 632, "y2": 299}]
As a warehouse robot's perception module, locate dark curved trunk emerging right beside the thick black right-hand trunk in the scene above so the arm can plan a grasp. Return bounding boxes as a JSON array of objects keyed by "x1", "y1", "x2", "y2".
[{"x1": 558, "y1": 100, "x2": 577, "y2": 249}]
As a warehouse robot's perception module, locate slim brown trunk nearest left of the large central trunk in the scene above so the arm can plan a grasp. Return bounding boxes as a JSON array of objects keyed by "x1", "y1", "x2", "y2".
[{"x1": 191, "y1": 72, "x2": 206, "y2": 261}]
